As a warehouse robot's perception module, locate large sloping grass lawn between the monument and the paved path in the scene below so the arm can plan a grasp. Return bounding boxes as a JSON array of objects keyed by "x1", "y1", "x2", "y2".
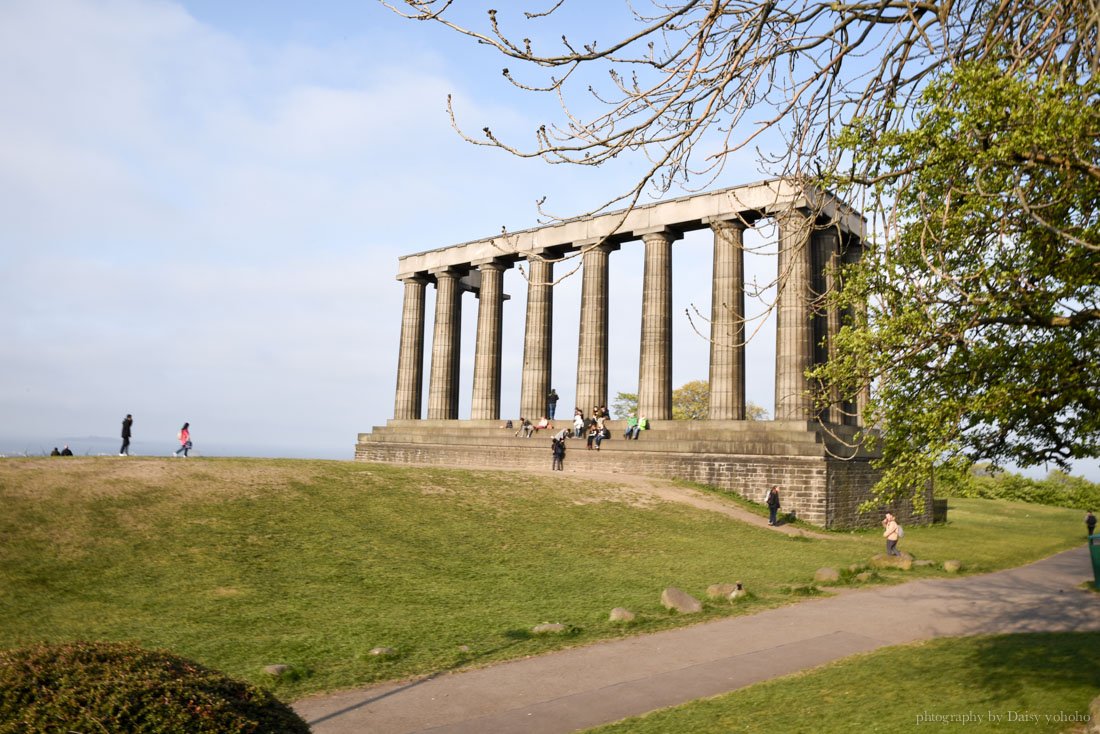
[{"x1": 0, "y1": 458, "x2": 1082, "y2": 699}]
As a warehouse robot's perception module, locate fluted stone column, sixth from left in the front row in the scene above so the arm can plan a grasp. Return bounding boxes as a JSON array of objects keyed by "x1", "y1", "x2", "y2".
[{"x1": 638, "y1": 228, "x2": 682, "y2": 420}]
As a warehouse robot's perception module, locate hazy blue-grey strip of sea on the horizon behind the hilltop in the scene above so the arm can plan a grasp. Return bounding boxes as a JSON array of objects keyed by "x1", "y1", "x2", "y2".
[{"x1": 0, "y1": 436, "x2": 355, "y2": 460}]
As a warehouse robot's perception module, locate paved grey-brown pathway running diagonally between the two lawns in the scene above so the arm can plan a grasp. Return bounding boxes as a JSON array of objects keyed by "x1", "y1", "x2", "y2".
[{"x1": 294, "y1": 547, "x2": 1100, "y2": 734}]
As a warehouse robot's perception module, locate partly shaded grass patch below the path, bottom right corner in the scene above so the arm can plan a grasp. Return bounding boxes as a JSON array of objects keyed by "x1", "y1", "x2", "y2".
[{"x1": 589, "y1": 633, "x2": 1100, "y2": 734}]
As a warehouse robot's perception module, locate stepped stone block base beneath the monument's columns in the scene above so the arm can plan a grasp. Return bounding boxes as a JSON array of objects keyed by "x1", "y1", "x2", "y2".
[{"x1": 355, "y1": 420, "x2": 933, "y2": 529}]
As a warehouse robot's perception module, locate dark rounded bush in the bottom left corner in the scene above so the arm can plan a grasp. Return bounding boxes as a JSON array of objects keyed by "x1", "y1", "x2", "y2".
[{"x1": 0, "y1": 643, "x2": 309, "y2": 734}]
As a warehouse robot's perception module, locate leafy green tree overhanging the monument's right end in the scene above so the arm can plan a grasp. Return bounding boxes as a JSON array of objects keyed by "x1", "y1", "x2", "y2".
[{"x1": 815, "y1": 64, "x2": 1100, "y2": 506}]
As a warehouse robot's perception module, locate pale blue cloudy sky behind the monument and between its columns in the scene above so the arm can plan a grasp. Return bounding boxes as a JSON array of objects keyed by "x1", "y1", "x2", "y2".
[{"x1": 0, "y1": 0, "x2": 1091, "y2": 479}]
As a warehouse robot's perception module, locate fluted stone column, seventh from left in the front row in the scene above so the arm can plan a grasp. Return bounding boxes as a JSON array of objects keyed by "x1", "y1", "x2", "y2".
[{"x1": 710, "y1": 220, "x2": 748, "y2": 420}]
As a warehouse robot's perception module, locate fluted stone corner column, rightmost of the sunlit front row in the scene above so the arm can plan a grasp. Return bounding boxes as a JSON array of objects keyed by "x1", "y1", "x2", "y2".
[{"x1": 776, "y1": 209, "x2": 813, "y2": 420}]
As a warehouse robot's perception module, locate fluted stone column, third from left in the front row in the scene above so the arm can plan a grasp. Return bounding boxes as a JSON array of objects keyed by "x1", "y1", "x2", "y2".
[{"x1": 470, "y1": 261, "x2": 507, "y2": 420}]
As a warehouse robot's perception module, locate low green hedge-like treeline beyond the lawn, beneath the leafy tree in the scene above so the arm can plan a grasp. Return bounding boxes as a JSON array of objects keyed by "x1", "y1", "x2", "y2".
[{"x1": 935, "y1": 464, "x2": 1100, "y2": 510}]
